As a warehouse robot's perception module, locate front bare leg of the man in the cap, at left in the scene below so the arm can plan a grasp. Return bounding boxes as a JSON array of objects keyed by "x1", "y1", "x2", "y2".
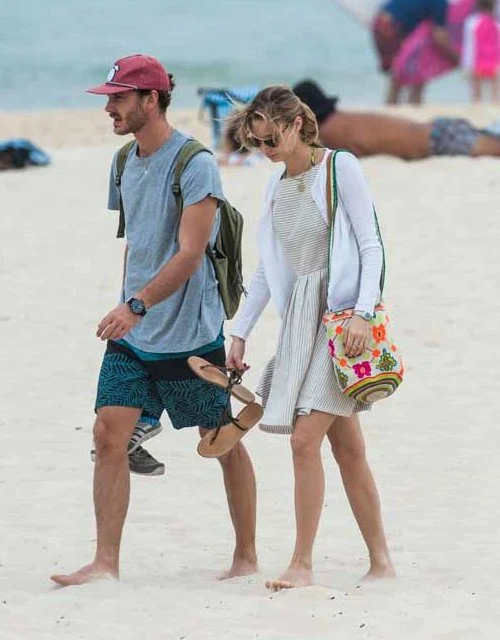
[{"x1": 51, "y1": 407, "x2": 141, "y2": 586}]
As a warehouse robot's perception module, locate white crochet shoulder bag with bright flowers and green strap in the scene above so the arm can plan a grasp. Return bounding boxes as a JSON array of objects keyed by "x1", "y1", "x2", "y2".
[{"x1": 323, "y1": 151, "x2": 404, "y2": 403}]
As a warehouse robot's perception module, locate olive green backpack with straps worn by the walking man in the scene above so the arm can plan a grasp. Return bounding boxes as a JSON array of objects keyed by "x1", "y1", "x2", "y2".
[{"x1": 115, "y1": 140, "x2": 246, "y2": 320}]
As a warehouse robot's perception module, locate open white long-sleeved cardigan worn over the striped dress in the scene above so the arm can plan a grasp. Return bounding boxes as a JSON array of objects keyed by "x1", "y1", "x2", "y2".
[{"x1": 231, "y1": 149, "x2": 384, "y2": 339}]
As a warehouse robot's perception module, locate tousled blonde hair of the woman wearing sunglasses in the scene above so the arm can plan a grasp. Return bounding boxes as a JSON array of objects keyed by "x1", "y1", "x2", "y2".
[{"x1": 228, "y1": 85, "x2": 319, "y2": 148}]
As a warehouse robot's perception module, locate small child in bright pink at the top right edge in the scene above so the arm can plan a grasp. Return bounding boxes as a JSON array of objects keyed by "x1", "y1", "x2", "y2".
[{"x1": 462, "y1": 0, "x2": 500, "y2": 102}]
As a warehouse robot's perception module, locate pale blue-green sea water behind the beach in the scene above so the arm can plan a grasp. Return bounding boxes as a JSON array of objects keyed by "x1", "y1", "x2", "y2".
[{"x1": 0, "y1": 0, "x2": 468, "y2": 110}]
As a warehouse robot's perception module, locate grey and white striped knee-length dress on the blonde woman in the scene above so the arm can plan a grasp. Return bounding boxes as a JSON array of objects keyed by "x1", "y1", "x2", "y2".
[{"x1": 257, "y1": 166, "x2": 370, "y2": 434}]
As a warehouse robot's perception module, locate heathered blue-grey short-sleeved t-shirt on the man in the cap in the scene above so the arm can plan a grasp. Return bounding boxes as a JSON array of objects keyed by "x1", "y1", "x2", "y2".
[{"x1": 108, "y1": 131, "x2": 225, "y2": 353}]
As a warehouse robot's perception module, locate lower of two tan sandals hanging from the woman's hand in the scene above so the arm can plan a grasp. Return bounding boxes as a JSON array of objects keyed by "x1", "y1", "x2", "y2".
[{"x1": 198, "y1": 402, "x2": 264, "y2": 458}]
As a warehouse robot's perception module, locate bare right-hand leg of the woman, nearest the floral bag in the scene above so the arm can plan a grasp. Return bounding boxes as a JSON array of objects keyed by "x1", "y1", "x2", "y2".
[{"x1": 328, "y1": 415, "x2": 396, "y2": 578}]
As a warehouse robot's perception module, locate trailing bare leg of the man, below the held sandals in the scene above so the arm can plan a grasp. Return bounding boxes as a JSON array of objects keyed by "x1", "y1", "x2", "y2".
[{"x1": 200, "y1": 429, "x2": 258, "y2": 580}]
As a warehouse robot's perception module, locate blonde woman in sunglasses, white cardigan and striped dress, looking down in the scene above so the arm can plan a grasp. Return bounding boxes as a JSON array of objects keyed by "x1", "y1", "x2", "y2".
[{"x1": 227, "y1": 86, "x2": 395, "y2": 591}]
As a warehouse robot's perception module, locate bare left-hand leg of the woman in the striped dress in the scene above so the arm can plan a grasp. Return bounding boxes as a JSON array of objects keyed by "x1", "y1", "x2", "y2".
[{"x1": 266, "y1": 411, "x2": 335, "y2": 591}]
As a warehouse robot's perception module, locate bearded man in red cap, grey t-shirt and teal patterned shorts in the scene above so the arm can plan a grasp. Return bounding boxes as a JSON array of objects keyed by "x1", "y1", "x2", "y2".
[{"x1": 52, "y1": 55, "x2": 257, "y2": 586}]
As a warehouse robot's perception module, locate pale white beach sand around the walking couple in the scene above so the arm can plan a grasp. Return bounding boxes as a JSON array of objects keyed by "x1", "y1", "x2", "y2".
[{"x1": 0, "y1": 109, "x2": 500, "y2": 640}]
